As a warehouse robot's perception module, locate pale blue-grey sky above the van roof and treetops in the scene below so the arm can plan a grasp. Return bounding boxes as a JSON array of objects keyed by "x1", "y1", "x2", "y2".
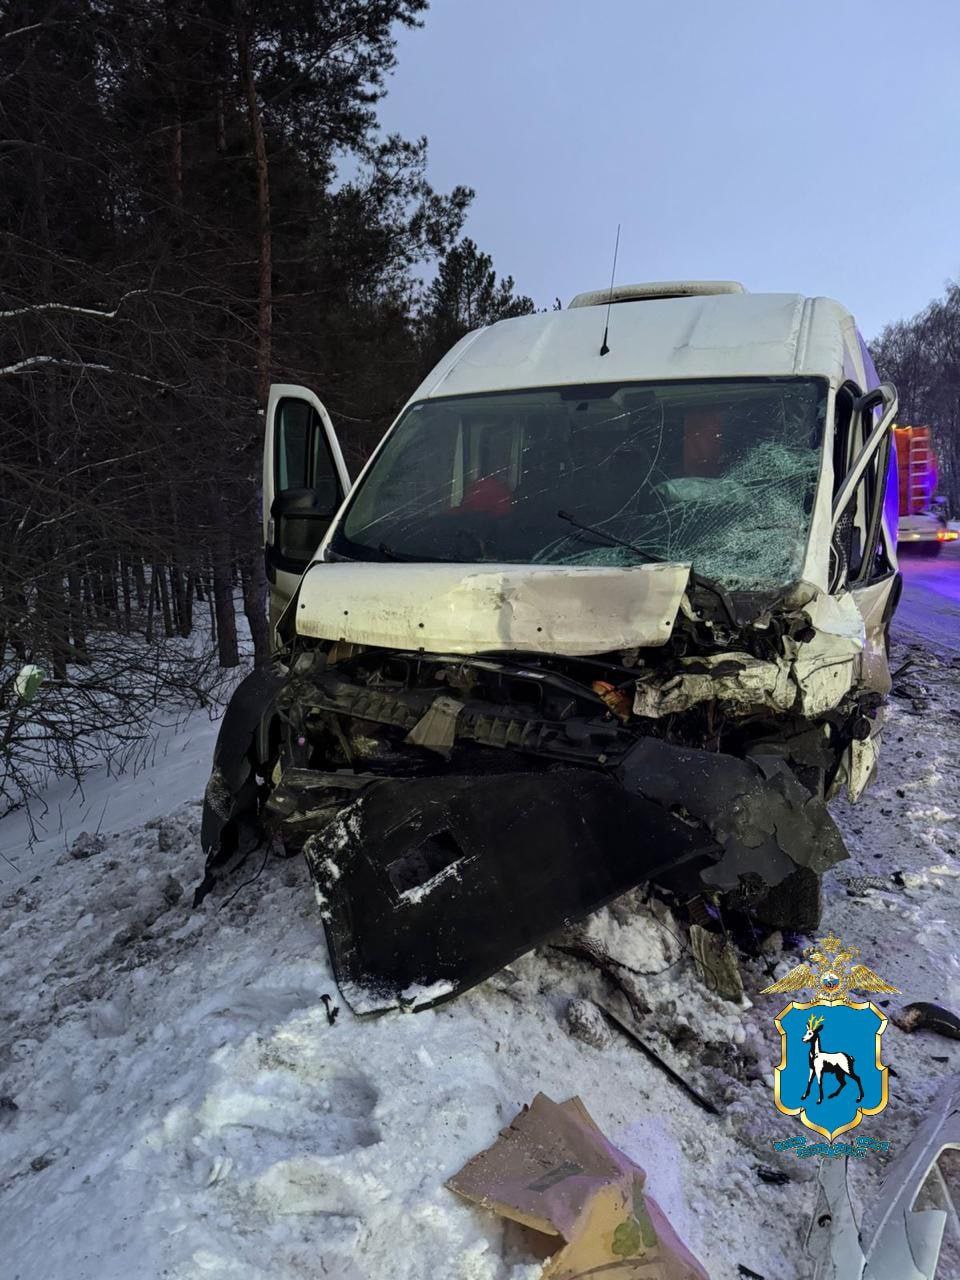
[{"x1": 380, "y1": 0, "x2": 960, "y2": 337}]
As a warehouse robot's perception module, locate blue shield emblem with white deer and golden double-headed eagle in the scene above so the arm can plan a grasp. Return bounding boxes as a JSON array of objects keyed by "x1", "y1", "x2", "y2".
[{"x1": 763, "y1": 934, "x2": 897, "y2": 1142}]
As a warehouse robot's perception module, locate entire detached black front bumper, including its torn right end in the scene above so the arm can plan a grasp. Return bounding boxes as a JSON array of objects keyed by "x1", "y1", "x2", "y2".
[{"x1": 268, "y1": 740, "x2": 846, "y2": 1014}]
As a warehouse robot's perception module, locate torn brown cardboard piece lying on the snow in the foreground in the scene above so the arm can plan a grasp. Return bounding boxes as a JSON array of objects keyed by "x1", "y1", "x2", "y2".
[{"x1": 447, "y1": 1093, "x2": 709, "y2": 1280}]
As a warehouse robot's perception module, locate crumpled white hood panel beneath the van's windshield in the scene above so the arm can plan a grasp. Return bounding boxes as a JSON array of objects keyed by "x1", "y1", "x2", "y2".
[{"x1": 293, "y1": 561, "x2": 690, "y2": 657}]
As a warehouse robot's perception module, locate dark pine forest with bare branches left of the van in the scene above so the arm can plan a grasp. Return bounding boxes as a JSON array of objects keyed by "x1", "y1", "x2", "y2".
[{"x1": 0, "y1": 0, "x2": 534, "y2": 817}]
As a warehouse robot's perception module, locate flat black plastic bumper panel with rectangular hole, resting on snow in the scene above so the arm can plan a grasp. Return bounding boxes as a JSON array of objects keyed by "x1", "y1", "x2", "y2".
[{"x1": 303, "y1": 768, "x2": 721, "y2": 1014}]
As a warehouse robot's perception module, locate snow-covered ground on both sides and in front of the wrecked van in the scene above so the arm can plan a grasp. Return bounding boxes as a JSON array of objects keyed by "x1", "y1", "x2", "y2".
[{"x1": 0, "y1": 558, "x2": 960, "y2": 1280}]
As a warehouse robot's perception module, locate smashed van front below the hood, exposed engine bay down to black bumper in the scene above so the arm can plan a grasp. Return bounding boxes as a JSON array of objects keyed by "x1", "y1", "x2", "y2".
[{"x1": 197, "y1": 566, "x2": 886, "y2": 1012}]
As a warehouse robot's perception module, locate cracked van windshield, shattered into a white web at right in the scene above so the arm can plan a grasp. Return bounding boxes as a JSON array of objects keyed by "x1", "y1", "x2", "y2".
[{"x1": 332, "y1": 378, "x2": 827, "y2": 590}]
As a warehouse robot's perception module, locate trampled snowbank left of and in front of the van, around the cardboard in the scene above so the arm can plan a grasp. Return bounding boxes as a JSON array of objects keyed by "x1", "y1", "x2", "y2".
[{"x1": 0, "y1": 805, "x2": 795, "y2": 1280}]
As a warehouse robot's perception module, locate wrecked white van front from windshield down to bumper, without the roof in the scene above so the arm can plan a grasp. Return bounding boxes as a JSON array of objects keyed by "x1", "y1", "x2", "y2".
[{"x1": 204, "y1": 288, "x2": 899, "y2": 1012}]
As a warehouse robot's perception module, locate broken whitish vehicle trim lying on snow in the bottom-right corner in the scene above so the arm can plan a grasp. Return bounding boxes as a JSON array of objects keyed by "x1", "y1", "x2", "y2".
[{"x1": 806, "y1": 1076, "x2": 960, "y2": 1280}]
